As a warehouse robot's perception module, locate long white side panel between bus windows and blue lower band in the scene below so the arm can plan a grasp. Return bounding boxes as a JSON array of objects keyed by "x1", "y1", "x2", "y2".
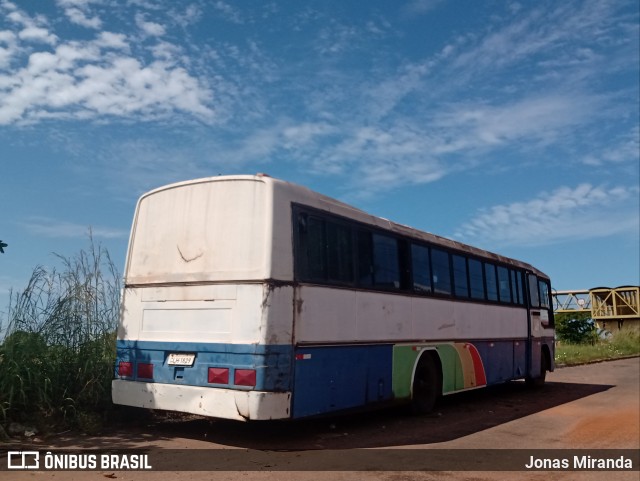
[{"x1": 295, "y1": 285, "x2": 527, "y2": 343}]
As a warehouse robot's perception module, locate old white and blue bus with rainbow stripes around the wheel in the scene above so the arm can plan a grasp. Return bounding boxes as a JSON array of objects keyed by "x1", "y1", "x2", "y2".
[{"x1": 112, "y1": 174, "x2": 554, "y2": 420}]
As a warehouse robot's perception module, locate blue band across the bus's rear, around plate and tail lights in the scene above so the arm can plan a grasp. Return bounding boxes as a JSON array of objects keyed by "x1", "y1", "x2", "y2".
[{"x1": 115, "y1": 340, "x2": 293, "y2": 392}]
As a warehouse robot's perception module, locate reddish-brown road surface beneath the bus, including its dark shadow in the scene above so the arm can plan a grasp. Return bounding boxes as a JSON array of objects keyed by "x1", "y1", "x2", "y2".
[{"x1": 0, "y1": 358, "x2": 640, "y2": 481}]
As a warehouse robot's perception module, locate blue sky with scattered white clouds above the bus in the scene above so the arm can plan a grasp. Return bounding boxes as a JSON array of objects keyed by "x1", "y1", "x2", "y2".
[{"x1": 0, "y1": 0, "x2": 640, "y2": 322}]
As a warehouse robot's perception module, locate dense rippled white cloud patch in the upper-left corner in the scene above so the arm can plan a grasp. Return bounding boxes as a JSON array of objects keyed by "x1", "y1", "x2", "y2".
[{"x1": 0, "y1": 1, "x2": 213, "y2": 125}]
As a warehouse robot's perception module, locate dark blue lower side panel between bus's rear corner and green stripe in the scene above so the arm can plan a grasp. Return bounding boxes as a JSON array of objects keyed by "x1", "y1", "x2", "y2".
[{"x1": 292, "y1": 345, "x2": 393, "y2": 418}]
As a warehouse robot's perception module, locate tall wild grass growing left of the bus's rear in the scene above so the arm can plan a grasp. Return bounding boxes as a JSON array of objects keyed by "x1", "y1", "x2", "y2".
[{"x1": 0, "y1": 233, "x2": 120, "y2": 430}]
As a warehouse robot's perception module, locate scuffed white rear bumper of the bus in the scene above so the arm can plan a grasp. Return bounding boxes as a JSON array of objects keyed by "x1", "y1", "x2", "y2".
[{"x1": 111, "y1": 379, "x2": 291, "y2": 421}]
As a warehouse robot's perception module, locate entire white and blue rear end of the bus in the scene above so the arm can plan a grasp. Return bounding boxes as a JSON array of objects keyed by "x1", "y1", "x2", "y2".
[{"x1": 112, "y1": 178, "x2": 292, "y2": 420}]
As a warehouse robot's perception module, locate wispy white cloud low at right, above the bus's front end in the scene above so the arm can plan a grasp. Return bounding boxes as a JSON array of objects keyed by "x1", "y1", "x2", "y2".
[{"x1": 455, "y1": 183, "x2": 640, "y2": 246}]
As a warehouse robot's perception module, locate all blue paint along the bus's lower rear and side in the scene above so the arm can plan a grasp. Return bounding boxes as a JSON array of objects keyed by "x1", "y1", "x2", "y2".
[{"x1": 116, "y1": 339, "x2": 544, "y2": 418}]
